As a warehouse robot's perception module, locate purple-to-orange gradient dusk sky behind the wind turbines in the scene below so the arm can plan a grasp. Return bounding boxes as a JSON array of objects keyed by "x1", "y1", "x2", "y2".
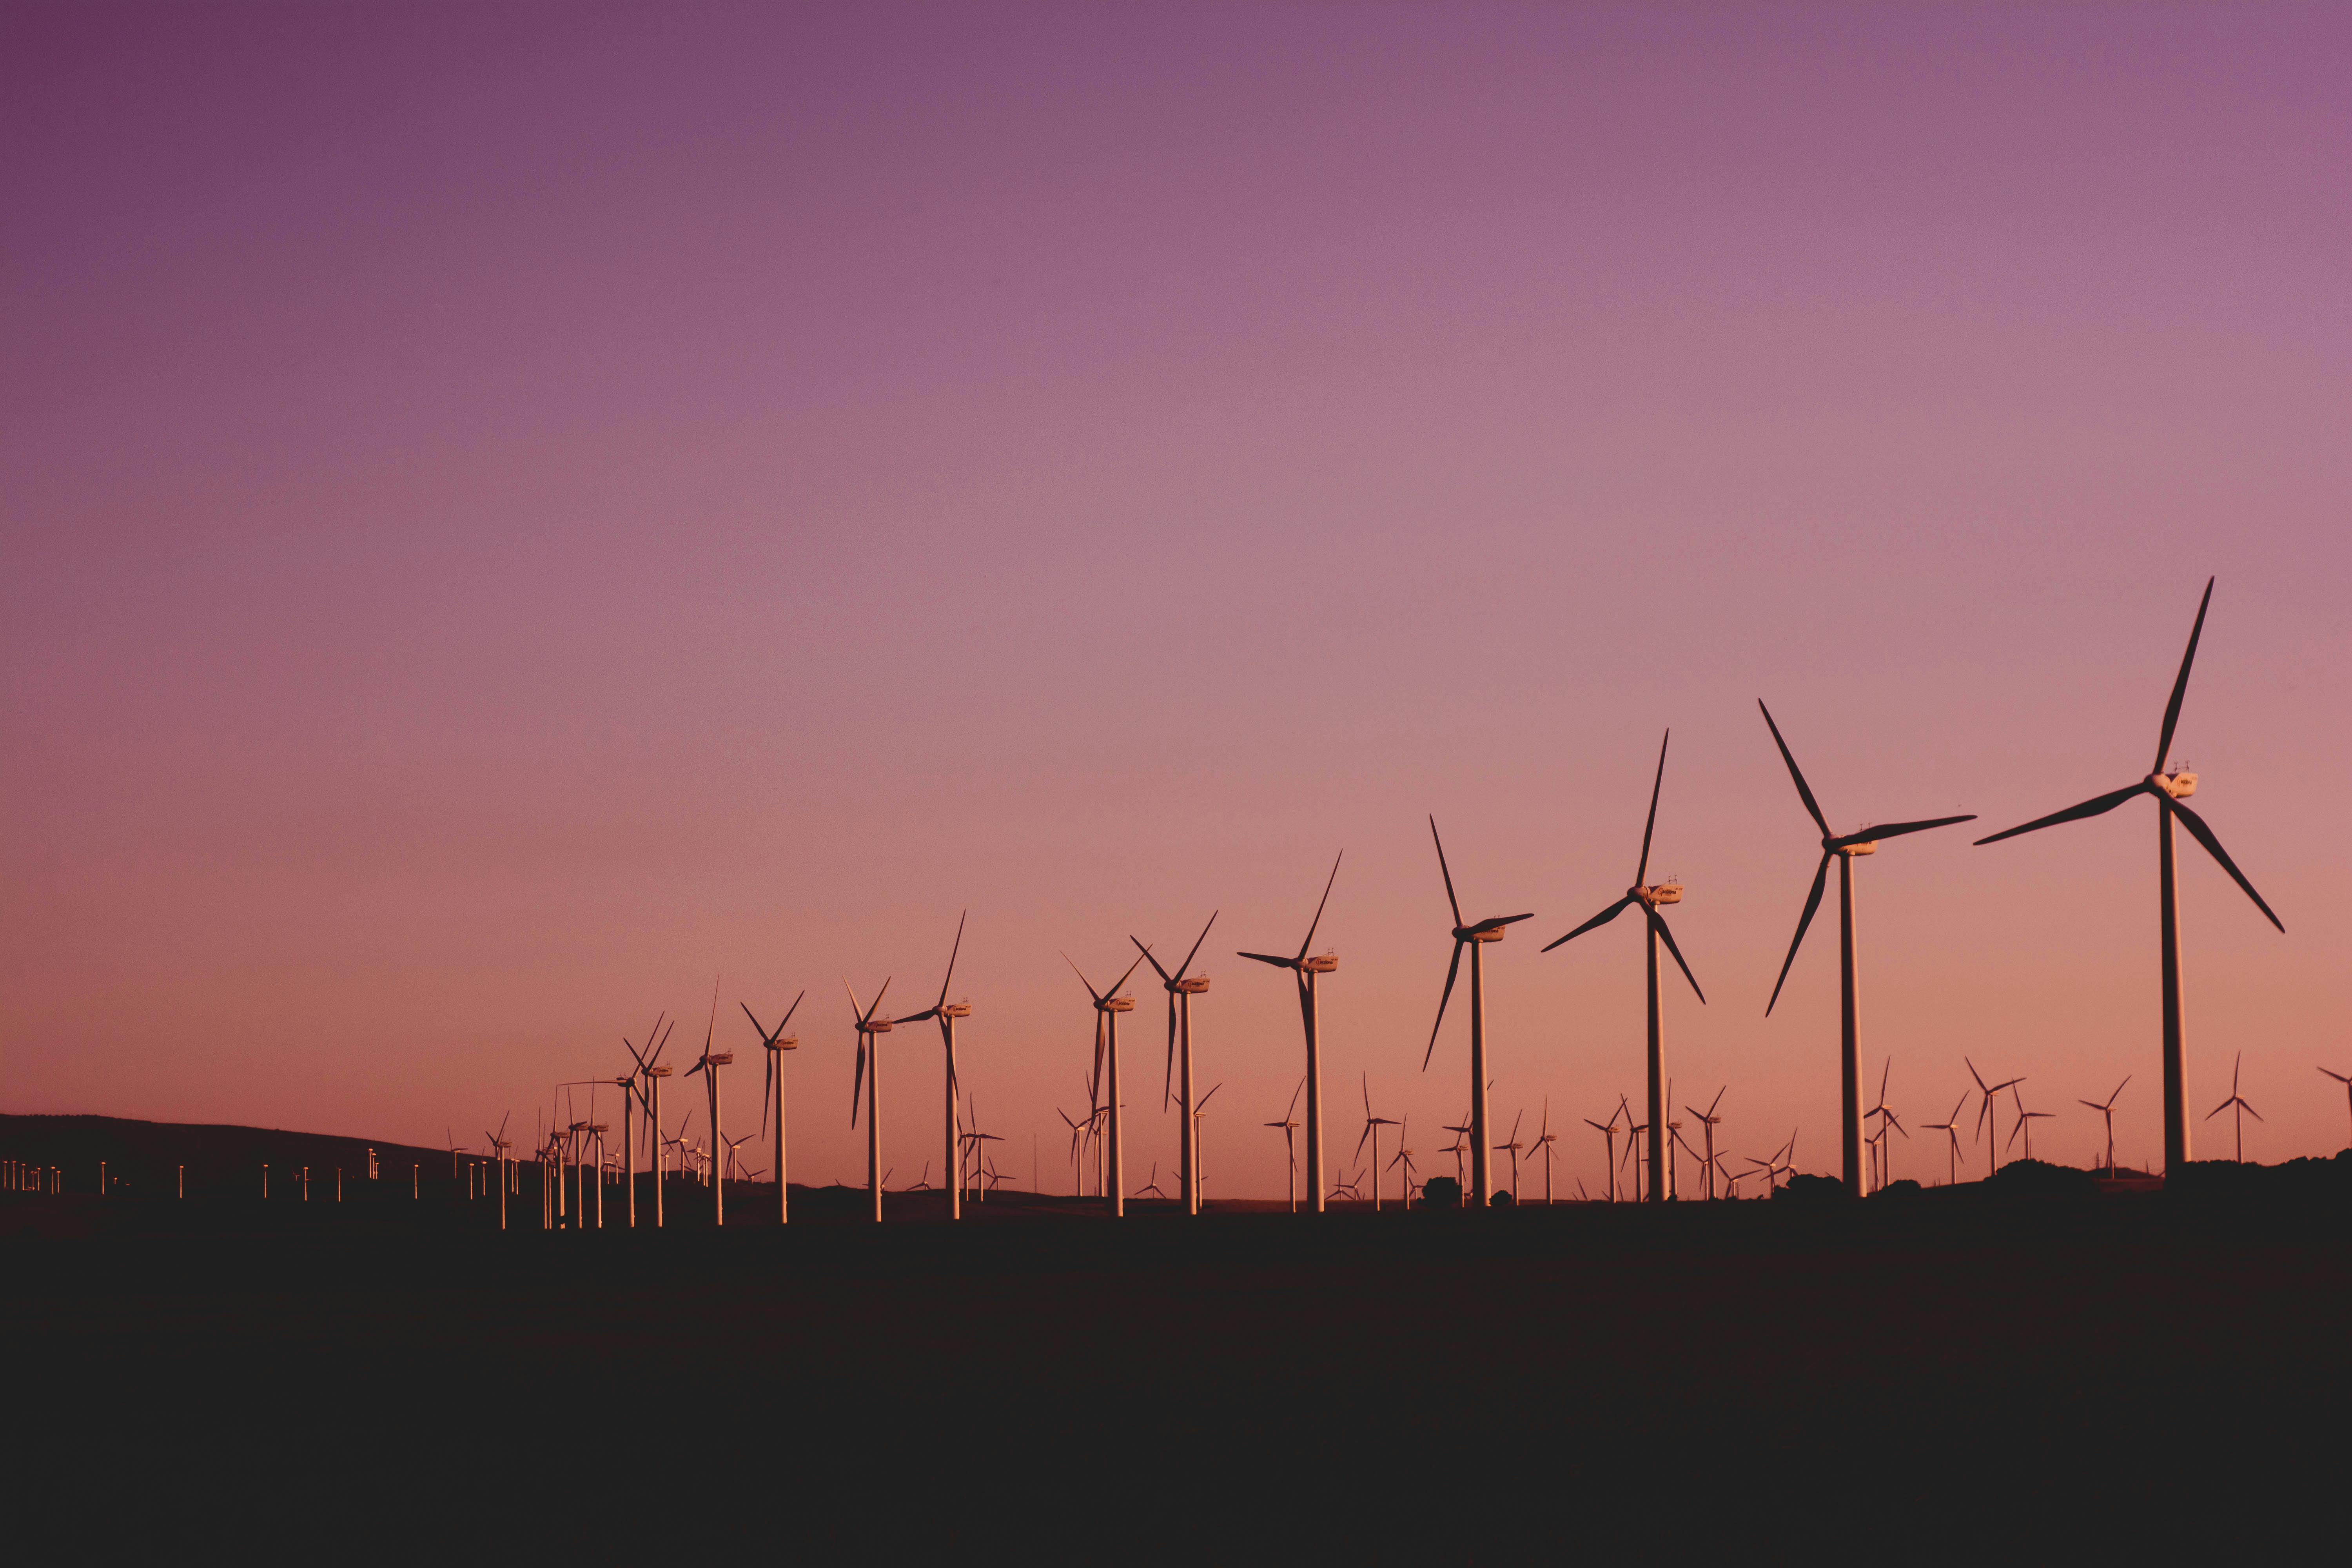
[{"x1": 0, "y1": 5, "x2": 2352, "y2": 1199}]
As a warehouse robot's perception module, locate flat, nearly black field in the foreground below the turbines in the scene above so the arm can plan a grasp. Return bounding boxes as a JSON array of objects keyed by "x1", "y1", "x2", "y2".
[{"x1": 0, "y1": 1166, "x2": 2352, "y2": 1561}]
